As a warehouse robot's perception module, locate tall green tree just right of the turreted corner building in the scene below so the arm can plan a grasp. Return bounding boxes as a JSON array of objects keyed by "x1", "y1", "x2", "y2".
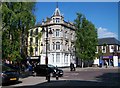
[{"x1": 75, "y1": 13, "x2": 97, "y2": 67}]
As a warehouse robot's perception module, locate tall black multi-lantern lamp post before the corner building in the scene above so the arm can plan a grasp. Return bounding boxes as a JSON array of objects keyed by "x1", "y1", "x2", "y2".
[{"x1": 42, "y1": 27, "x2": 52, "y2": 82}]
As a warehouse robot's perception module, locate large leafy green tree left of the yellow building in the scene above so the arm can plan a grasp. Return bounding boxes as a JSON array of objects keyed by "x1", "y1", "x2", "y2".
[{"x1": 2, "y1": 2, "x2": 35, "y2": 61}]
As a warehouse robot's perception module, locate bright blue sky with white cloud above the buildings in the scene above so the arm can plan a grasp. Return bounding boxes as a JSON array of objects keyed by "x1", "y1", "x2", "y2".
[{"x1": 35, "y1": 2, "x2": 118, "y2": 39}]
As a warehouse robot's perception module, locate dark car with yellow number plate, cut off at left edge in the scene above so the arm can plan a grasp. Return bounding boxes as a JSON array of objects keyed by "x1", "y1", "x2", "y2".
[{"x1": 0, "y1": 65, "x2": 19, "y2": 84}]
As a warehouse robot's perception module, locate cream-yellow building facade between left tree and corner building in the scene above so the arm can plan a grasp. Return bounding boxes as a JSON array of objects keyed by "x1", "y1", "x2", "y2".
[{"x1": 27, "y1": 26, "x2": 42, "y2": 62}]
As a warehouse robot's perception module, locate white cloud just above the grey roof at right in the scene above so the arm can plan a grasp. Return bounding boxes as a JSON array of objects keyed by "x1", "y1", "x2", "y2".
[{"x1": 98, "y1": 27, "x2": 118, "y2": 39}]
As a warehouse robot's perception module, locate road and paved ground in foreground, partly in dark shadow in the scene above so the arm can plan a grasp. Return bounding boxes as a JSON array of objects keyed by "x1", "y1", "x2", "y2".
[{"x1": 3, "y1": 68, "x2": 120, "y2": 88}]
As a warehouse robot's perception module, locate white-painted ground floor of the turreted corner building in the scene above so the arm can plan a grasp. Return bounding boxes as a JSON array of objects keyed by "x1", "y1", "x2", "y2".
[{"x1": 40, "y1": 52, "x2": 75, "y2": 67}]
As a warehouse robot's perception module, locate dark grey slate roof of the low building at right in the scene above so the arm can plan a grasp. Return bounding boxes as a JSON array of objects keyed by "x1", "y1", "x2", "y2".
[{"x1": 98, "y1": 37, "x2": 120, "y2": 45}]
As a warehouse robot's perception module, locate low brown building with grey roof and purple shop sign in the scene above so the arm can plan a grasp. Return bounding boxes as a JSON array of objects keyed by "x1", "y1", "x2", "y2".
[{"x1": 94, "y1": 37, "x2": 120, "y2": 66}]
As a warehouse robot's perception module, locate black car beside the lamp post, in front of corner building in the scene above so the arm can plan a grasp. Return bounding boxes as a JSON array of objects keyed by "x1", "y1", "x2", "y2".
[{"x1": 34, "y1": 64, "x2": 63, "y2": 77}]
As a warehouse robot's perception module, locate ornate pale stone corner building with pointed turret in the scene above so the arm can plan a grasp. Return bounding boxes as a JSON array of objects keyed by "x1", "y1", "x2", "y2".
[{"x1": 40, "y1": 7, "x2": 76, "y2": 67}]
